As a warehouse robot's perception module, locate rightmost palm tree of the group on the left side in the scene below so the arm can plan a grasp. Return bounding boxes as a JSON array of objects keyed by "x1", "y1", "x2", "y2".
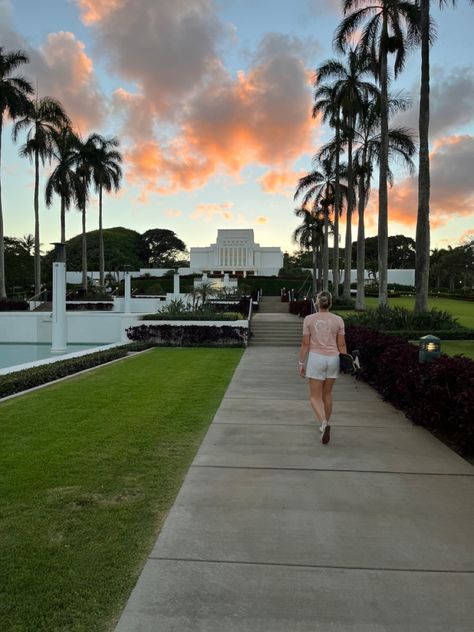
[{"x1": 91, "y1": 134, "x2": 122, "y2": 287}]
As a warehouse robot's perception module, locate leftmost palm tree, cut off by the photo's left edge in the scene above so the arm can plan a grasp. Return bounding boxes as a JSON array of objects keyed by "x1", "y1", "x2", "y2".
[{"x1": 0, "y1": 46, "x2": 33, "y2": 298}]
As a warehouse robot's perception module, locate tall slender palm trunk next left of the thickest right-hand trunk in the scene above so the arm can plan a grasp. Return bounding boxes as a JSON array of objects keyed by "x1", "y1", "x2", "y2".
[{"x1": 378, "y1": 24, "x2": 388, "y2": 305}]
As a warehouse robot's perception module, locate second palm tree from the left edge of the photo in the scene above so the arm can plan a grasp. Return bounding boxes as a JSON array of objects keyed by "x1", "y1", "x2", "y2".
[{"x1": 12, "y1": 97, "x2": 70, "y2": 294}]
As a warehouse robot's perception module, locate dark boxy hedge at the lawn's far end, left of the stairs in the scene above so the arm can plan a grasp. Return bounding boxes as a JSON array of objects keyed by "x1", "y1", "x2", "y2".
[{"x1": 127, "y1": 325, "x2": 248, "y2": 347}]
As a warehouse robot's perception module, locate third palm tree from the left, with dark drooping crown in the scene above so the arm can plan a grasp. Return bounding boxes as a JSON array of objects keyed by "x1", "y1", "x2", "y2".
[{"x1": 45, "y1": 127, "x2": 82, "y2": 249}]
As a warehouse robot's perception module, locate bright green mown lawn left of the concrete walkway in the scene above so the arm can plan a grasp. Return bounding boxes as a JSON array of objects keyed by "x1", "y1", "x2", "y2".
[{"x1": 0, "y1": 349, "x2": 242, "y2": 632}]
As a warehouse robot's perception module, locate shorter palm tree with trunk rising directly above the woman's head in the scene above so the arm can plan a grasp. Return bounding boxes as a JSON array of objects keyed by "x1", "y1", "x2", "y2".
[{"x1": 294, "y1": 156, "x2": 347, "y2": 290}]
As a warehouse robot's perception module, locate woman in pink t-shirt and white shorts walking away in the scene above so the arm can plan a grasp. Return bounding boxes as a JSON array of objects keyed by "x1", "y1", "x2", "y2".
[{"x1": 298, "y1": 292, "x2": 347, "y2": 444}]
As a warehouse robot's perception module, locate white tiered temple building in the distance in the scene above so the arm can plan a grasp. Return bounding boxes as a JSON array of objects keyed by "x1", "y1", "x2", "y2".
[{"x1": 190, "y1": 228, "x2": 283, "y2": 276}]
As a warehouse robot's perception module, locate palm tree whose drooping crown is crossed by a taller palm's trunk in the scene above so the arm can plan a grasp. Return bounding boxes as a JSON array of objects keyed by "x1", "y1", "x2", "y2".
[{"x1": 354, "y1": 98, "x2": 416, "y2": 310}]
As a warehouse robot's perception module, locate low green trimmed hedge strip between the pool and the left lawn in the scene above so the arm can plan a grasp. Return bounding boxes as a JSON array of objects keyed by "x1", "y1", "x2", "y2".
[{"x1": 0, "y1": 345, "x2": 132, "y2": 398}]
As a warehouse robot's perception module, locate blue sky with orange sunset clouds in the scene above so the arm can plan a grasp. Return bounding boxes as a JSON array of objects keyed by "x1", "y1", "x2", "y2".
[{"x1": 0, "y1": 0, "x2": 474, "y2": 252}]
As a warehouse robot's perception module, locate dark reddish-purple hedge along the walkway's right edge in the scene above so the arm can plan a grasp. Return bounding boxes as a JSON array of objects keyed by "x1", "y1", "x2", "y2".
[{"x1": 346, "y1": 325, "x2": 474, "y2": 457}]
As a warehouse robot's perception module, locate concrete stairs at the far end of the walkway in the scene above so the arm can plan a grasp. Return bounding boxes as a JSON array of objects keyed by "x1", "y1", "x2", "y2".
[{"x1": 249, "y1": 296, "x2": 303, "y2": 347}]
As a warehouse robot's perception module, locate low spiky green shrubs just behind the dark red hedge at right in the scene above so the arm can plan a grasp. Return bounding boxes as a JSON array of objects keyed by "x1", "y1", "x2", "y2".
[{"x1": 346, "y1": 305, "x2": 462, "y2": 331}]
